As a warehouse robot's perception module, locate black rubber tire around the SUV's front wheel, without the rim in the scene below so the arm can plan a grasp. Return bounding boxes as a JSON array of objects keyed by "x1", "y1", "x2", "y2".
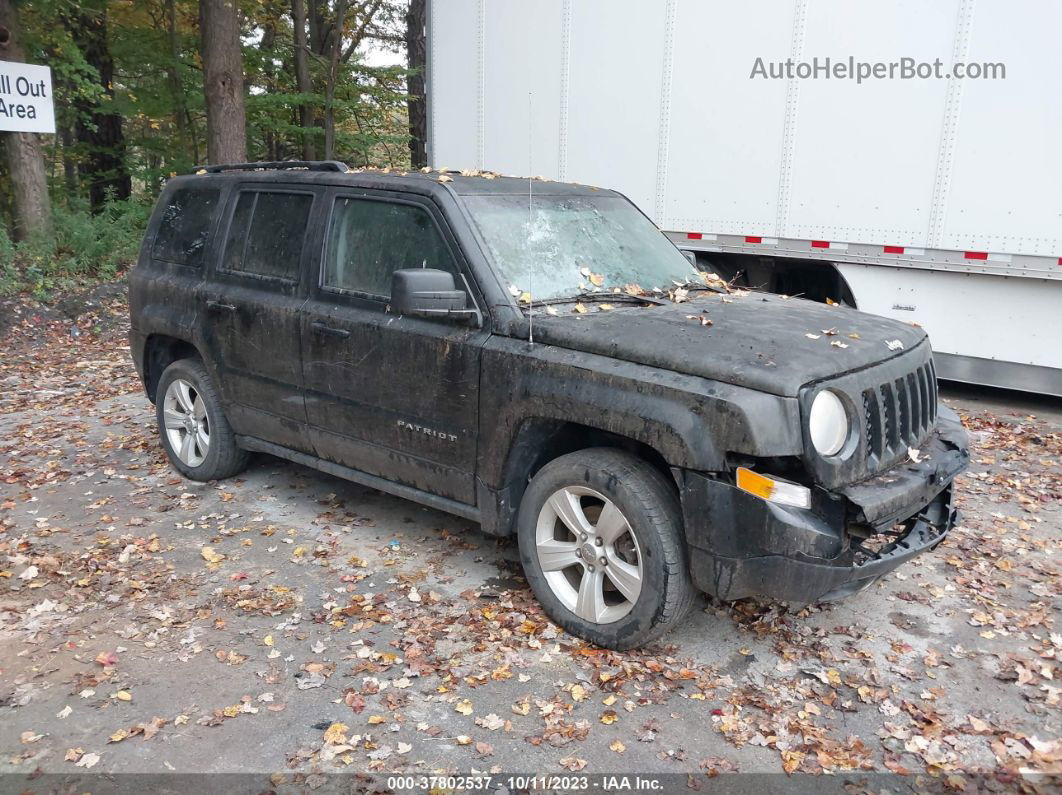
[{"x1": 517, "y1": 448, "x2": 696, "y2": 650}]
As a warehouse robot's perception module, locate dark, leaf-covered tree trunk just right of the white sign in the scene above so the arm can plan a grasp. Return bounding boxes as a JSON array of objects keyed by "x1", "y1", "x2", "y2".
[{"x1": 70, "y1": 0, "x2": 133, "y2": 211}]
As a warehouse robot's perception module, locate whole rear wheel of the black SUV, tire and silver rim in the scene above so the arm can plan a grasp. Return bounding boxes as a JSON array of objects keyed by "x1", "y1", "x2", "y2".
[{"x1": 155, "y1": 359, "x2": 249, "y2": 481}]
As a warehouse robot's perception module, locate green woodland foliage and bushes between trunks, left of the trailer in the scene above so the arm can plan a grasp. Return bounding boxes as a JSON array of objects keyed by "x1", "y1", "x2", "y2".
[{"x1": 0, "y1": 0, "x2": 409, "y2": 292}]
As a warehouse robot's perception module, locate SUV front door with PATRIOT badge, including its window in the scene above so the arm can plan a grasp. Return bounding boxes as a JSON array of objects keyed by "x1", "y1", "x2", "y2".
[{"x1": 303, "y1": 191, "x2": 487, "y2": 505}]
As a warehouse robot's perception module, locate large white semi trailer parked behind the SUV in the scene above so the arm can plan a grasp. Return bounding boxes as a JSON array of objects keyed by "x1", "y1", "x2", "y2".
[{"x1": 427, "y1": 0, "x2": 1062, "y2": 395}]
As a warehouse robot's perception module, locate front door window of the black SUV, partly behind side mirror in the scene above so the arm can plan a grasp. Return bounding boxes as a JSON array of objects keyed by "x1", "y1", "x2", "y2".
[{"x1": 324, "y1": 197, "x2": 458, "y2": 298}]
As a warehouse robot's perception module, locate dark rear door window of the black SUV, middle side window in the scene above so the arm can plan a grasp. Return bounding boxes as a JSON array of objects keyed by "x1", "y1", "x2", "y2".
[{"x1": 222, "y1": 191, "x2": 313, "y2": 281}]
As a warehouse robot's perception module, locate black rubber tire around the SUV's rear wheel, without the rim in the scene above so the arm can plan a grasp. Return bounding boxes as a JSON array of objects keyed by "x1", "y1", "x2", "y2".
[{"x1": 155, "y1": 359, "x2": 250, "y2": 481}]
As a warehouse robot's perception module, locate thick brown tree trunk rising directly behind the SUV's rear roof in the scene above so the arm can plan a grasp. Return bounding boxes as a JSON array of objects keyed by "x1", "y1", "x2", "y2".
[{"x1": 200, "y1": 0, "x2": 247, "y2": 163}]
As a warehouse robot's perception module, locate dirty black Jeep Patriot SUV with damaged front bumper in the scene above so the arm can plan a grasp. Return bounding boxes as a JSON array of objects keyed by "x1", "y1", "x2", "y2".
[{"x1": 130, "y1": 162, "x2": 969, "y2": 649}]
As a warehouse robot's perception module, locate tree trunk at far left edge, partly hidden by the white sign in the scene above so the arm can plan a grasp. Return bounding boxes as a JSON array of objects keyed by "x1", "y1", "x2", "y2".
[{"x1": 0, "y1": 0, "x2": 52, "y2": 240}]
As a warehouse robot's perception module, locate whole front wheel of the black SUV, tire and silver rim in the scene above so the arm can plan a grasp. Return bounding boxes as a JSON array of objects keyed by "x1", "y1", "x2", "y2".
[{"x1": 517, "y1": 448, "x2": 695, "y2": 650}]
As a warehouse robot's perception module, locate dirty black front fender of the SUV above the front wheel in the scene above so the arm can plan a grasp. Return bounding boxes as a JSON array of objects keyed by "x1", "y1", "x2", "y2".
[{"x1": 479, "y1": 336, "x2": 802, "y2": 488}]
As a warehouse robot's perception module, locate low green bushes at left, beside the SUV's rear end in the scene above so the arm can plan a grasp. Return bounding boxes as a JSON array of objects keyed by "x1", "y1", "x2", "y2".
[{"x1": 0, "y1": 200, "x2": 151, "y2": 296}]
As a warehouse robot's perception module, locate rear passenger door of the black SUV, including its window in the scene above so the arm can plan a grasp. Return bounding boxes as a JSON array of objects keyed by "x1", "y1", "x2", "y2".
[{"x1": 203, "y1": 185, "x2": 318, "y2": 452}]
